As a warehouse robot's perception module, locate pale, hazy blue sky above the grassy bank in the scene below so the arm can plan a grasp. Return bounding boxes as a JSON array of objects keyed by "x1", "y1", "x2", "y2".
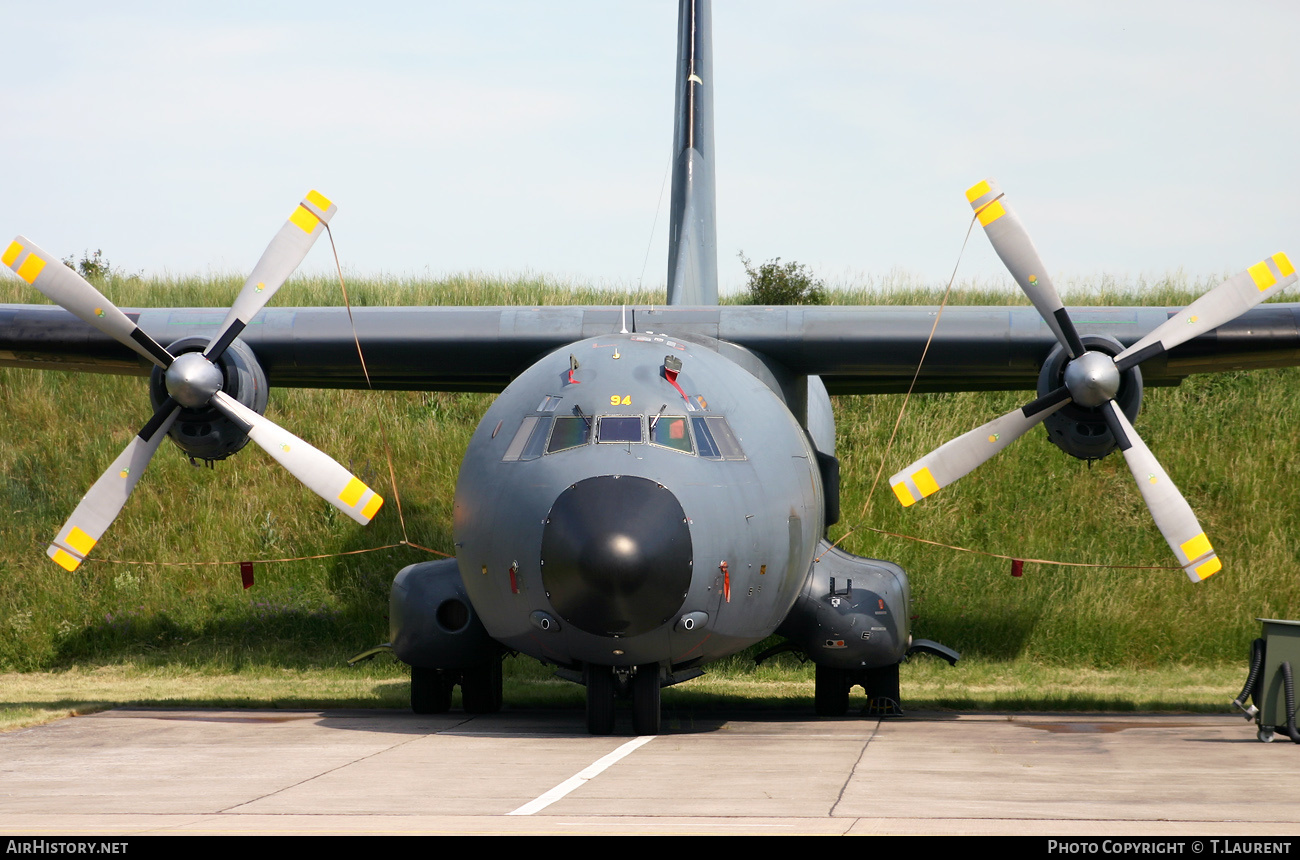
[{"x1": 0, "y1": 0, "x2": 1300, "y2": 291}]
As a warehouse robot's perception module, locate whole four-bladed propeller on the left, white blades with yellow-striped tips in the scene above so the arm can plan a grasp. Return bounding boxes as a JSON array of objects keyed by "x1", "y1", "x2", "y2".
[{"x1": 0, "y1": 191, "x2": 384, "y2": 570}]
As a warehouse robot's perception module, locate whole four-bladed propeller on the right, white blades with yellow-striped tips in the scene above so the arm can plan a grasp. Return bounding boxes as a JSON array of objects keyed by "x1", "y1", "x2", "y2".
[{"x1": 889, "y1": 179, "x2": 1296, "y2": 582}]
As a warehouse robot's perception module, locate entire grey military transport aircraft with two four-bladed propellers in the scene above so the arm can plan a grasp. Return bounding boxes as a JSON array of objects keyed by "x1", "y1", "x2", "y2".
[{"x1": 0, "y1": 0, "x2": 1300, "y2": 734}]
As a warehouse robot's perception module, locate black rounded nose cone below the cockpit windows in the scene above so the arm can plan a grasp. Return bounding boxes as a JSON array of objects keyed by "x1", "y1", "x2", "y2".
[{"x1": 542, "y1": 475, "x2": 692, "y2": 637}]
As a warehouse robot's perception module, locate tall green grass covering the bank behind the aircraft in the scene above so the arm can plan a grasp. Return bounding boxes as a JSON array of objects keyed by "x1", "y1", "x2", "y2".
[{"x1": 0, "y1": 274, "x2": 1300, "y2": 672}]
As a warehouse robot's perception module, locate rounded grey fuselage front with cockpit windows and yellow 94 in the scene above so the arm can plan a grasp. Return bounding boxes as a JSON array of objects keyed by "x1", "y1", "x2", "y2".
[{"x1": 455, "y1": 333, "x2": 824, "y2": 668}]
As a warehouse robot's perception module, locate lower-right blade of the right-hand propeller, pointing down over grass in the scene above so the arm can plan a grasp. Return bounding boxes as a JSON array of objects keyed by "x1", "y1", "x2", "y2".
[{"x1": 1101, "y1": 400, "x2": 1223, "y2": 582}]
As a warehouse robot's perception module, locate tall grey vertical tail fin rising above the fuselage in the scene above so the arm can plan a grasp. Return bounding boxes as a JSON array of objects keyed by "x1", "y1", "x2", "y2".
[{"x1": 668, "y1": 0, "x2": 718, "y2": 305}]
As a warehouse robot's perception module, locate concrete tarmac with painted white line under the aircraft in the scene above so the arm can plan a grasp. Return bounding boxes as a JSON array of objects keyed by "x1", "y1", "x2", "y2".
[{"x1": 0, "y1": 709, "x2": 1300, "y2": 839}]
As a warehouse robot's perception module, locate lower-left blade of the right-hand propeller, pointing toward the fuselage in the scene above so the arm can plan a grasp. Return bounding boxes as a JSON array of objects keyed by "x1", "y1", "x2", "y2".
[{"x1": 889, "y1": 387, "x2": 1070, "y2": 508}]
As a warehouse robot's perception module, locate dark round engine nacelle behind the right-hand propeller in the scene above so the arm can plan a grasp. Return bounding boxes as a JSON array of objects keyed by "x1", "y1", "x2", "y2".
[{"x1": 1039, "y1": 334, "x2": 1141, "y2": 460}]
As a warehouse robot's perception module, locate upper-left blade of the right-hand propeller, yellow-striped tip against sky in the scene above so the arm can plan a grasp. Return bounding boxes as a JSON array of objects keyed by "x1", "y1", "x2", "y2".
[{"x1": 966, "y1": 179, "x2": 1084, "y2": 359}]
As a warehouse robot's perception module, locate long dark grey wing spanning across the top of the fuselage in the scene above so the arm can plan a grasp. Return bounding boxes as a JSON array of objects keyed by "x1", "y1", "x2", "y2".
[{"x1": 0, "y1": 304, "x2": 1300, "y2": 394}]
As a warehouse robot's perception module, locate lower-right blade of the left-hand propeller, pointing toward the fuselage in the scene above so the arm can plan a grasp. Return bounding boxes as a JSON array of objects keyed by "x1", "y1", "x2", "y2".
[{"x1": 212, "y1": 391, "x2": 384, "y2": 526}]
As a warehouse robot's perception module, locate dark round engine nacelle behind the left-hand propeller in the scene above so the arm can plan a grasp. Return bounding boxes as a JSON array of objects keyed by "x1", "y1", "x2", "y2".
[{"x1": 150, "y1": 336, "x2": 268, "y2": 461}]
